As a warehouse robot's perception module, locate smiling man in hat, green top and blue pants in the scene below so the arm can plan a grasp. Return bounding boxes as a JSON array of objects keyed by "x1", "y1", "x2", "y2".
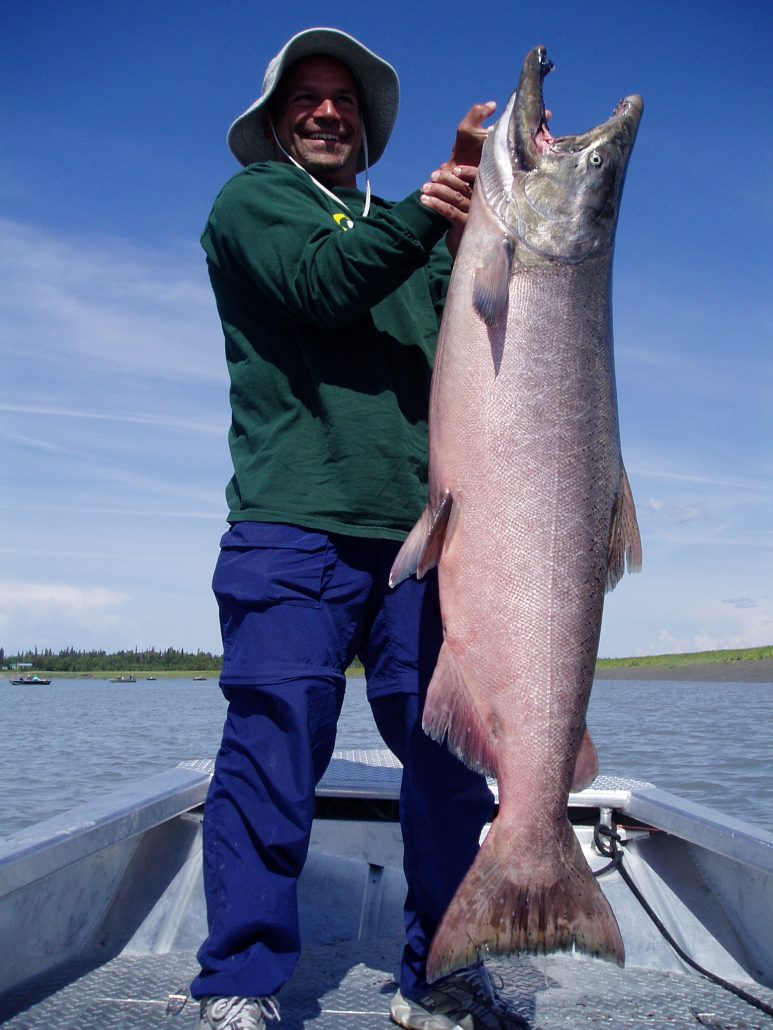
[{"x1": 192, "y1": 29, "x2": 522, "y2": 1030}]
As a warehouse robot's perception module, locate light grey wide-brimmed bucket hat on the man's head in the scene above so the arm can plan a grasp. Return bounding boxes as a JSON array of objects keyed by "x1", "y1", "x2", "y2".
[{"x1": 228, "y1": 28, "x2": 400, "y2": 172}]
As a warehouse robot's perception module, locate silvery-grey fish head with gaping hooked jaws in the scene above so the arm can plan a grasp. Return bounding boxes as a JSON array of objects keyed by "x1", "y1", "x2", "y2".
[{"x1": 478, "y1": 46, "x2": 643, "y2": 264}]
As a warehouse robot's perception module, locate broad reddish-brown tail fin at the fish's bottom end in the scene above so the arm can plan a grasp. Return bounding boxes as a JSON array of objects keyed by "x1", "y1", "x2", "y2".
[{"x1": 427, "y1": 820, "x2": 625, "y2": 983}]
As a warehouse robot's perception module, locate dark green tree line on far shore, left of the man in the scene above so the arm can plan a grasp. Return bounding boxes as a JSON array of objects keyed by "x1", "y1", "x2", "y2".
[{"x1": 0, "y1": 647, "x2": 223, "y2": 673}]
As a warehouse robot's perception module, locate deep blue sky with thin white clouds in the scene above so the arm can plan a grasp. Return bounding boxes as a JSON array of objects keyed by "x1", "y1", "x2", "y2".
[{"x1": 0, "y1": 0, "x2": 773, "y2": 656}]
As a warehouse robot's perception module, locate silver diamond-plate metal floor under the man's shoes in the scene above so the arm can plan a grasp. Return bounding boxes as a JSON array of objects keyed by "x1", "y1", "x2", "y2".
[{"x1": 0, "y1": 938, "x2": 773, "y2": 1030}]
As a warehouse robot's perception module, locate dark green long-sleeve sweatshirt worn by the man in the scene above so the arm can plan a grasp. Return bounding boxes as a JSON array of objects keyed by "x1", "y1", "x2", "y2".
[{"x1": 202, "y1": 162, "x2": 450, "y2": 540}]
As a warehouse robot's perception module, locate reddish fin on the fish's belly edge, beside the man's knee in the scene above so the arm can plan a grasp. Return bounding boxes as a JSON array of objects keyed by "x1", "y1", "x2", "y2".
[{"x1": 422, "y1": 643, "x2": 494, "y2": 776}]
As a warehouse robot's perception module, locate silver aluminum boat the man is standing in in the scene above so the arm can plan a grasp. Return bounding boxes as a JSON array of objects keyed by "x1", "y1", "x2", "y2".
[{"x1": 0, "y1": 751, "x2": 773, "y2": 1030}]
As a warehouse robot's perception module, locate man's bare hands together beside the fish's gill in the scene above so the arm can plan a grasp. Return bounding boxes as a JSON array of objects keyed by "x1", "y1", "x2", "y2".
[{"x1": 422, "y1": 101, "x2": 497, "y2": 256}]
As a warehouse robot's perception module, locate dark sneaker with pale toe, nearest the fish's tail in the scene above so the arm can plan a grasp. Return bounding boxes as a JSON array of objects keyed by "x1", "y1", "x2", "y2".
[{"x1": 390, "y1": 965, "x2": 529, "y2": 1030}]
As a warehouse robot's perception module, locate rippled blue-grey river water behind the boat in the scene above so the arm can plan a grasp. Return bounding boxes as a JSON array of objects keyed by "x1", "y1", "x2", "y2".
[{"x1": 0, "y1": 679, "x2": 773, "y2": 836}]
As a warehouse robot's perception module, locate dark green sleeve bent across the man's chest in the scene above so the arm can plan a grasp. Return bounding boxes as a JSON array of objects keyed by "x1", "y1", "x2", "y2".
[{"x1": 202, "y1": 163, "x2": 447, "y2": 329}]
